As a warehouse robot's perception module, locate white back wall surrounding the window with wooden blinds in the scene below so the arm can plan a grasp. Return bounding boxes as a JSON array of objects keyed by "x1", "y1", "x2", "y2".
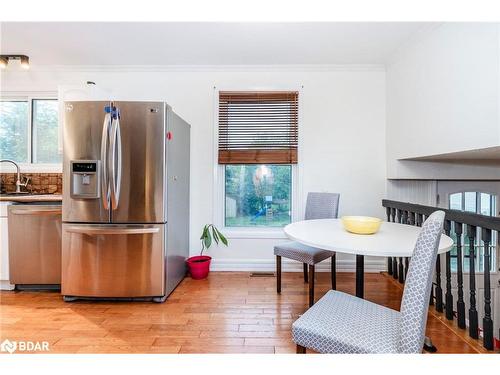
[{"x1": 1, "y1": 67, "x2": 386, "y2": 270}]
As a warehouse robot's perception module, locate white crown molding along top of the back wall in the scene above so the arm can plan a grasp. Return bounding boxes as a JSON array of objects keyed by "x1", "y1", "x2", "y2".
[{"x1": 2, "y1": 64, "x2": 385, "y2": 74}]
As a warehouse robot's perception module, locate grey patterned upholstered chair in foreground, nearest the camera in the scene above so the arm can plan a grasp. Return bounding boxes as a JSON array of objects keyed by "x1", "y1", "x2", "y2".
[{"x1": 292, "y1": 211, "x2": 444, "y2": 353}]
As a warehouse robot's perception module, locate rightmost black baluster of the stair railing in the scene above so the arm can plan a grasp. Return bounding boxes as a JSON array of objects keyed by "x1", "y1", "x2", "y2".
[{"x1": 481, "y1": 228, "x2": 493, "y2": 350}]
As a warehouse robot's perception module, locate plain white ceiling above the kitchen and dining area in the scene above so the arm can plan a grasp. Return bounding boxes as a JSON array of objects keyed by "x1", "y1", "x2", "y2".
[{"x1": 0, "y1": 22, "x2": 429, "y2": 66}]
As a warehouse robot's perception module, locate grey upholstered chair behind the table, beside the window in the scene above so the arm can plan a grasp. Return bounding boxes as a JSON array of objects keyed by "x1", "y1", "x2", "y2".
[{"x1": 274, "y1": 193, "x2": 340, "y2": 306}]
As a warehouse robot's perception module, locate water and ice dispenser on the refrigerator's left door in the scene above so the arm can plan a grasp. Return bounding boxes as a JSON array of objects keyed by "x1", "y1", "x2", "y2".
[{"x1": 70, "y1": 160, "x2": 101, "y2": 199}]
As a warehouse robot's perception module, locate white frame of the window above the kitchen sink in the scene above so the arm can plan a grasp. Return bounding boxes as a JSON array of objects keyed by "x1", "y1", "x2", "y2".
[{"x1": 0, "y1": 91, "x2": 62, "y2": 173}]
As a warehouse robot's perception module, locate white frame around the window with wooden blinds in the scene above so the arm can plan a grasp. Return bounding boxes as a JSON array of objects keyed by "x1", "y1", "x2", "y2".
[{"x1": 212, "y1": 86, "x2": 304, "y2": 239}]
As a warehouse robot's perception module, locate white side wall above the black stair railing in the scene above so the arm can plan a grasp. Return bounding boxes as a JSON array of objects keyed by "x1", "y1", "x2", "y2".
[{"x1": 387, "y1": 23, "x2": 500, "y2": 179}]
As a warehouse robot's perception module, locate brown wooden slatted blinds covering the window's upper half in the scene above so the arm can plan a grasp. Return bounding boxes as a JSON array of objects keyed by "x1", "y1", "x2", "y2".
[{"x1": 219, "y1": 91, "x2": 299, "y2": 164}]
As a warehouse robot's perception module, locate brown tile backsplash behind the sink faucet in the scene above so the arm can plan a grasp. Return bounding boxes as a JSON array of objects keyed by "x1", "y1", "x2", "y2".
[{"x1": 0, "y1": 173, "x2": 62, "y2": 194}]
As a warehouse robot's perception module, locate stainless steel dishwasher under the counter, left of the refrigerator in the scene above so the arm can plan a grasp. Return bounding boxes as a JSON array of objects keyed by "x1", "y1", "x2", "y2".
[{"x1": 8, "y1": 203, "x2": 62, "y2": 289}]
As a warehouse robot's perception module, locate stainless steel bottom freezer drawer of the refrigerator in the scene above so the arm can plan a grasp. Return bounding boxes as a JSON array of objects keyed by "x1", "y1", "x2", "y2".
[{"x1": 61, "y1": 223, "x2": 165, "y2": 298}]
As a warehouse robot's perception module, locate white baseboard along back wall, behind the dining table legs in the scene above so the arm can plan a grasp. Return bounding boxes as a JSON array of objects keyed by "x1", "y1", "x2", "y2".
[{"x1": 210, "y1": 258, "x2": 387, "y2": 272}]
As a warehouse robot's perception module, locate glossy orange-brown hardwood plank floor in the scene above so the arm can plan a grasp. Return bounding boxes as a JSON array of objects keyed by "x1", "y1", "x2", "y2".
[{"x1": 0, "y1": 272, "x2": 481, "y2": 353}]
